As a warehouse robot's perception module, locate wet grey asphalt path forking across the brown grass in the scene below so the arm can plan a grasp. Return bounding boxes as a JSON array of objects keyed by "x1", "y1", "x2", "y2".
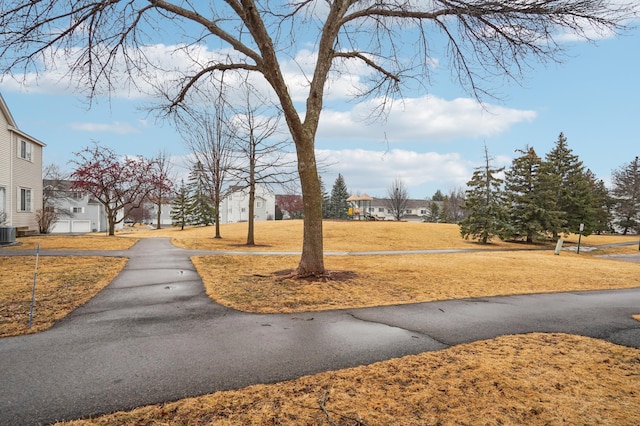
[{"x1": 0, "y1": 239, "x2": 640, "y2": 425}]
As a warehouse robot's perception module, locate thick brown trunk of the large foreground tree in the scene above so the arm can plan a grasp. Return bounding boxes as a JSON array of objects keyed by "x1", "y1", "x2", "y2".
[{"x1": 296, "y1": 139, "x2": 325, "y2": 277}]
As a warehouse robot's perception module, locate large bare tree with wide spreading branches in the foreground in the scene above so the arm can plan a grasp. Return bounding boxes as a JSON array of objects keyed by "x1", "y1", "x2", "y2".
[{"x1": 0, "y1": 0, "x2": 637, "y2": 276}]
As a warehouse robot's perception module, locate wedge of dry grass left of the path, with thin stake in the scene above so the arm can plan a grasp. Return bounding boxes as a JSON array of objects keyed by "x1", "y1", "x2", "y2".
[{"x1": 0, "y1": 256, "x2": 126, "y2": 337}]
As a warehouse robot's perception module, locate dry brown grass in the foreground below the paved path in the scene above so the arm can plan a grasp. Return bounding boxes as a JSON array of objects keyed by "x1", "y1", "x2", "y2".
[{"x1": 58, "y1": 333, "x2": 640, "y2": 426}]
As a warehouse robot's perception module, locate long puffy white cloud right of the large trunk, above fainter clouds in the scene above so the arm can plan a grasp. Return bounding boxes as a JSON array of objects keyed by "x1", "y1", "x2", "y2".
[{"x1": 318, "y1": 96, "x2": 537, "y2": 143}]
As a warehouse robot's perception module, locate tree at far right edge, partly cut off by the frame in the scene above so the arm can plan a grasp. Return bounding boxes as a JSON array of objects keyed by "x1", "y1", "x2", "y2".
[{"x1": 611, "y1": 157, "x2": 640, "y2": 235}]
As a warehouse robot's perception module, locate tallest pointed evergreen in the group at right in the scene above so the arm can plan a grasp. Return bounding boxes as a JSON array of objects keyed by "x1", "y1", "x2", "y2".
[{"x1": 544, "y1": 133, "x2": 596, "y2": 238}]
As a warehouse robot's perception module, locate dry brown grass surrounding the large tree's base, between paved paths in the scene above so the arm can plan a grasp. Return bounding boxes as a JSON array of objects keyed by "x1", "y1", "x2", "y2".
[{"x1": 192, "y1": 250, "x2": 640, "y2": 312}]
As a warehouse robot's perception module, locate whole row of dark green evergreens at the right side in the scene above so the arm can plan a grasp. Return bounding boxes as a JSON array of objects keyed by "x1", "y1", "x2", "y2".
[{"x1": 460, "y1": 133, "x2": 640, "y2": 243}]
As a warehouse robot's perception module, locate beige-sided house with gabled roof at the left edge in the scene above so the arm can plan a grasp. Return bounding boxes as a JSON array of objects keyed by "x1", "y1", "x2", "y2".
[{"x1": 0, "y1": 94, "x2": 45, "y2": 235}]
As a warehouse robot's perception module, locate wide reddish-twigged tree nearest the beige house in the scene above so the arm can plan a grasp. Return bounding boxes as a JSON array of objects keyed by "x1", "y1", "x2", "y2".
[{"x1": 71, "y1": 143, "x2": 161, "y2": 235}]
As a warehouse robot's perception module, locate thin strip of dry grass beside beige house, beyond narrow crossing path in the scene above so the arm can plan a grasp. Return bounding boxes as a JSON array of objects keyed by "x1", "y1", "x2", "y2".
[{"x1": 5, "y1": 235, "x2": 138, "y2": 254}]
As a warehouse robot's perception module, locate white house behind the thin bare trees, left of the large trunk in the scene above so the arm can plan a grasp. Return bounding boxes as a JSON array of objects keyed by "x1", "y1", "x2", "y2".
[{"x1": 220, "y1": 185, "x2": 276, "y2": 223}]
